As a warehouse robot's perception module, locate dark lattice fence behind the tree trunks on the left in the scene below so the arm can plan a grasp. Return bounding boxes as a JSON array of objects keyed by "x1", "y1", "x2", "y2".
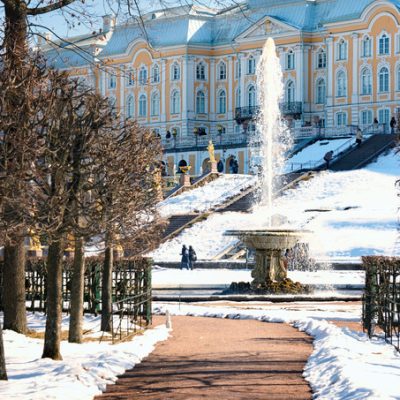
[{"x1": 0, "y1": 257, "x2": 151, "y2": 322}]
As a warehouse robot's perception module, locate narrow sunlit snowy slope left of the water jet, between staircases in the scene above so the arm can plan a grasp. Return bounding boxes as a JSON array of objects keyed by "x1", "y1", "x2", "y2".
[{"x1": 159, "y1": 175, "x2": 256, "y2": 217}]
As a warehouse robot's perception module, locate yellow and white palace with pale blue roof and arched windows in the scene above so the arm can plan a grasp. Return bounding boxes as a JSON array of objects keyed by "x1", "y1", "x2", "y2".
[{"x1": 41, "y1": 0, "x2": 400, "y2": 174}]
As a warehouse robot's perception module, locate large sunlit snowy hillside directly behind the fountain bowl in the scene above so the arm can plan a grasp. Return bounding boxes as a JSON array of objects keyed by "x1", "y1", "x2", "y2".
[{"x1": 153, "y1": 151, "x2": 399, "y2": 262}]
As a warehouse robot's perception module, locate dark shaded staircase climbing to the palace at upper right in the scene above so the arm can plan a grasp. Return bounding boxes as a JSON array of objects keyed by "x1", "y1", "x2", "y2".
[{"x1": 329, "y1": 134, "x2": 396, "y2": 171}]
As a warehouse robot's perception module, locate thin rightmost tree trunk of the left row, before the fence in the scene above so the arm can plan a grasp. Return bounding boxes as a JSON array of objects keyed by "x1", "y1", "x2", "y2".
[{"x1": 101, "y1": 241, "x2": 114, "y2": 332}]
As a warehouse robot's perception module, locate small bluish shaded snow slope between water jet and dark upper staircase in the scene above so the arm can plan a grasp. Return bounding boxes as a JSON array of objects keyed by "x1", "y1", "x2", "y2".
[{"x1": 285, "y1": 138, "x2": 355, "y2": 172}]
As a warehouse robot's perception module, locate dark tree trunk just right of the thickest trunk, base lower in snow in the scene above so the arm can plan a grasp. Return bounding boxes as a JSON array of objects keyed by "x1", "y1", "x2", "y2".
[{"x1": 42, "y1": 238, "x2": 64, "y2": 360}]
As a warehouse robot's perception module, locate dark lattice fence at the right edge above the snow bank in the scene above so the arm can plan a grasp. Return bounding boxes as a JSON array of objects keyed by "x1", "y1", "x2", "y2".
[{"x1": 362, "y1": 256, "x2": 400, "y2": 351}]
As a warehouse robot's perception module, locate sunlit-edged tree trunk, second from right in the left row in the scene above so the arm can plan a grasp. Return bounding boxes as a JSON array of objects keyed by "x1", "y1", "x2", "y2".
[{"x1": 68, "y1": 238, "x2": 85, "y2": 343}]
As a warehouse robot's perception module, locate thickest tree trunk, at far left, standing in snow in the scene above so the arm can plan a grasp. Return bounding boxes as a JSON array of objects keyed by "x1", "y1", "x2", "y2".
[{"x1": 3, "y1": 234, "x2": 27, "y2": 334}]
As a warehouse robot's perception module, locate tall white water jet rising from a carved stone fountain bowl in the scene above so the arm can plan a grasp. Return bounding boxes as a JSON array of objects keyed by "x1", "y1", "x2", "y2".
[{"x1": 225, "y1": 38, "x2": 310, "y2": 292}]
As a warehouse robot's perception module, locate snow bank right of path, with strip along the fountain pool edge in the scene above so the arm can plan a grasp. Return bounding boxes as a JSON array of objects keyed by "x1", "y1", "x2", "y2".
[{"x1": 153, "y1": 303, "x2": 400, "y2": 400}]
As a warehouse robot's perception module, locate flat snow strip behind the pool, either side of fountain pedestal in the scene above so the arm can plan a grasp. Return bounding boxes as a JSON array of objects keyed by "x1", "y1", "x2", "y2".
[{"x1": 152, "y1": 267, "x2": 365, "y2": 288}]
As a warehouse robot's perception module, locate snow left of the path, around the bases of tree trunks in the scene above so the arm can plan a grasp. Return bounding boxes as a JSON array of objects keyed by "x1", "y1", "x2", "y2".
[{"x1": 0, "y1": 313, "x2": 169, "y2": 400}]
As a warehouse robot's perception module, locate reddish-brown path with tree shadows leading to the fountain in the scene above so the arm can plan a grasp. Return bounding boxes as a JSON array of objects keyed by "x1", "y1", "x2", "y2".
[{"x1": 95, "y1": 317, "x2": 312, "y2": 400}]
